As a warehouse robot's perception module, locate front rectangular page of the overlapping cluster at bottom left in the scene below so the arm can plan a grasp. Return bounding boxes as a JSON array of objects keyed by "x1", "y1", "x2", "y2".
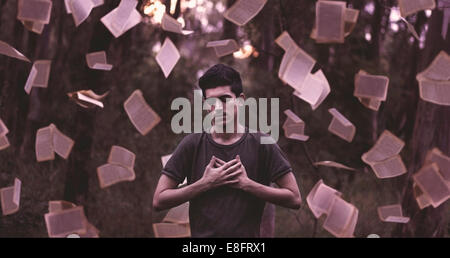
[{"x1": 44, "y1": 206, "x2": 88, "y2": 237}]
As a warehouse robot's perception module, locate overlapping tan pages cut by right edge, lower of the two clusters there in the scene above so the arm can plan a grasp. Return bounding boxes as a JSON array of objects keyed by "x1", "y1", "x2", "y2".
[{"x1": 413, "y1": 148, "x2": 450, "y2": 209}]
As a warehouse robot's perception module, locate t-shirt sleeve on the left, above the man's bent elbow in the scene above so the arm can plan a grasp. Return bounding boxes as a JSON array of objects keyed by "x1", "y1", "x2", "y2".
[{"x1": 161, "y1": 135, "x2": 194, "y2": 184}]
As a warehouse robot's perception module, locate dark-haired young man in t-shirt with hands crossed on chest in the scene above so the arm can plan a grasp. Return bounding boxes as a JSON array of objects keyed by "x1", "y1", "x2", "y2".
[{"x1": 153, "y1": 64, "x2": 301, "y2": 237}]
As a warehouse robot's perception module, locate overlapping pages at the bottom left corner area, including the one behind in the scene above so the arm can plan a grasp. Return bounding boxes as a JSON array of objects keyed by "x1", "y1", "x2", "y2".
[{"x1": 44, "y1": 201, "x2": 99, "y2": 238}]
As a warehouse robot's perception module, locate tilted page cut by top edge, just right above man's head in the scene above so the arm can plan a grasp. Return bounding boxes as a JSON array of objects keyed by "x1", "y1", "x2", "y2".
[{"x1": 223, "y1": 0, "x2": 267, "y2": 26}]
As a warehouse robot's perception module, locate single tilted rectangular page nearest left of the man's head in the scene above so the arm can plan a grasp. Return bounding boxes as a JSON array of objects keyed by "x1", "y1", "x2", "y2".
[{"x1": 123, "y1": 90, "x2": 161, "y2": 135}]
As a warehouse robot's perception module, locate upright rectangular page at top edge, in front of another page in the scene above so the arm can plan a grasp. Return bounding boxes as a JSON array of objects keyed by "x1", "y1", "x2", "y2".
[{"x1": 314, "y1": 1, "x2": 347, "y2": 43}]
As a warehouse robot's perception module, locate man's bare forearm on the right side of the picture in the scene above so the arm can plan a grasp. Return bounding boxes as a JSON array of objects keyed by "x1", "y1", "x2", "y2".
[{"x1": 243, "y1": 179, "x2": 301, "y2": 209}]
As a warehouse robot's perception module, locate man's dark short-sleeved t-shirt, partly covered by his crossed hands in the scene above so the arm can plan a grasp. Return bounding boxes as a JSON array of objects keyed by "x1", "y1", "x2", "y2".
[{"x1": 162, "y1": 132, "x2": 292, "y2": 237}]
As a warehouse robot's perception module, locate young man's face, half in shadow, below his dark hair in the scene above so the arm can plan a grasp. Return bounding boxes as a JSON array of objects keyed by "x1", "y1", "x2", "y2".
[{"x1": 205, "y1": 85, "x2": 244, "y2": 130}]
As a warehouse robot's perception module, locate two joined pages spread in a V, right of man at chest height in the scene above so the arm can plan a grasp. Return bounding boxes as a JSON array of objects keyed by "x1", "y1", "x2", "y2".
[{"x1": 361, "y1": 130, "x2": 407, "y2": 178}]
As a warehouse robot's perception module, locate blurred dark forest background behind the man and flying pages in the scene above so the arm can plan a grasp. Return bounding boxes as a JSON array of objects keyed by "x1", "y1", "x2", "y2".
[{"x1": 0, "y1": 0, "x2": 450, "y2": 237}]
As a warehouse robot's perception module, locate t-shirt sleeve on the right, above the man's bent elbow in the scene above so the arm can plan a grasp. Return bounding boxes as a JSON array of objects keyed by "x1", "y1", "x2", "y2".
[{"x1": 266, "y1": 143, "x2": 292, "y2": 182}]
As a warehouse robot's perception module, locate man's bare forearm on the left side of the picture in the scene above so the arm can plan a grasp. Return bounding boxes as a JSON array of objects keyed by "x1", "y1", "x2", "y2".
[{"x1": 154, "y1": 180, "x2": 208, "y2": 210}]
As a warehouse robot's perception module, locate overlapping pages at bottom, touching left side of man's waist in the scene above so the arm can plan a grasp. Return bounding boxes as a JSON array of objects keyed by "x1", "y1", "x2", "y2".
[{"x1": 153, "y1": 202, "x2": 191, "y2": 238}]
